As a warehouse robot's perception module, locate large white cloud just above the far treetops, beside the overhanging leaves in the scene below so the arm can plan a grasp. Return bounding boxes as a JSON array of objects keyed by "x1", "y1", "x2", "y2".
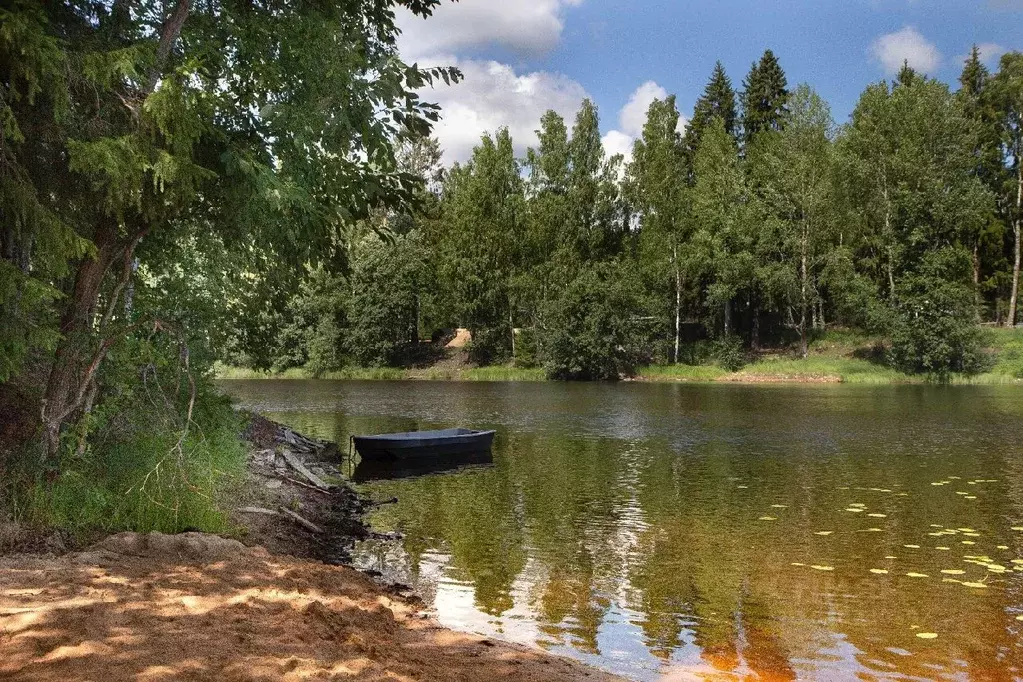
[{"x1": 422, "y1": 57, "x2": 588, "y2": 166}]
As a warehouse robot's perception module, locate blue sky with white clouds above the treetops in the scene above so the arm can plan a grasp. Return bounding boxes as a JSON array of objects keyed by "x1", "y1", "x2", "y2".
[{"x1": 400, "y1": 0, "x2": 1023, "y2": 163}]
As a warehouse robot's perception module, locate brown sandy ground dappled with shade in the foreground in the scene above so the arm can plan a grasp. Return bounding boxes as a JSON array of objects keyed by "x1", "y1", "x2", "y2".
[{"x1": 0, "y1": 533, "x2": 618, "y2": 682}]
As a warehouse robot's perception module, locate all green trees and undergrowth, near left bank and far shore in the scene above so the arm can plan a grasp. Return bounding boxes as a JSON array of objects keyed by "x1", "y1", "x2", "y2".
[{"x1": 0, "y1": 0, "x2": 1023, "y2": 529}]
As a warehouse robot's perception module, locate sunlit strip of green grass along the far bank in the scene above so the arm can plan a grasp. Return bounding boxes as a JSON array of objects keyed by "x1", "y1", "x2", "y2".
[{"x1": 211, "y1": 329, "x2": 1023, "y2": 384}]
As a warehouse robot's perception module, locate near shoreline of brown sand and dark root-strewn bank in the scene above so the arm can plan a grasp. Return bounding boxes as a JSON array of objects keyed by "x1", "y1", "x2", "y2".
[{"x1": 0, "y1": 414, "x2": 625, "y2": 682}]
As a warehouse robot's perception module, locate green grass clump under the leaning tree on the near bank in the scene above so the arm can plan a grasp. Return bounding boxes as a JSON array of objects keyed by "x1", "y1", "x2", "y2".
[{"x1": 13, "y1": 395, "x2": 246, "y2": 540}]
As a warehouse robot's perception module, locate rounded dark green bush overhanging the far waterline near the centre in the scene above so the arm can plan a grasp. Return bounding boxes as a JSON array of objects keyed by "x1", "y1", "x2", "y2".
[{"x1": 541, "y1": 264, "x2": 639, "y2": 379}]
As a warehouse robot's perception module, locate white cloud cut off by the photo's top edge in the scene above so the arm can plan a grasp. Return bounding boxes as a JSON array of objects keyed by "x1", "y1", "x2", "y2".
[{"x1": 398, "y1": 0, "x2": 582, "y2": 61}]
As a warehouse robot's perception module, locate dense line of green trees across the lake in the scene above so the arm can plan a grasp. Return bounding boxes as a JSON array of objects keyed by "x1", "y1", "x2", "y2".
[{"x1": 268, "y1": 49, "x2": 1023, "y2": 378}]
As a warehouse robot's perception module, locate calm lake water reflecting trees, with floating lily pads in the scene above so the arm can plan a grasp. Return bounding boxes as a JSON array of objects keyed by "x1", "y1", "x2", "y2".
[{"x1": 224, "y1": 380, "x2": 1023, "y2": 680}]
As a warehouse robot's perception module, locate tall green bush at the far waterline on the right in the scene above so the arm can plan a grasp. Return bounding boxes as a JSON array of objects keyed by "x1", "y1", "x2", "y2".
[{"x1": 888, "y1": 248, "x2": 990, "y2": 381}]
